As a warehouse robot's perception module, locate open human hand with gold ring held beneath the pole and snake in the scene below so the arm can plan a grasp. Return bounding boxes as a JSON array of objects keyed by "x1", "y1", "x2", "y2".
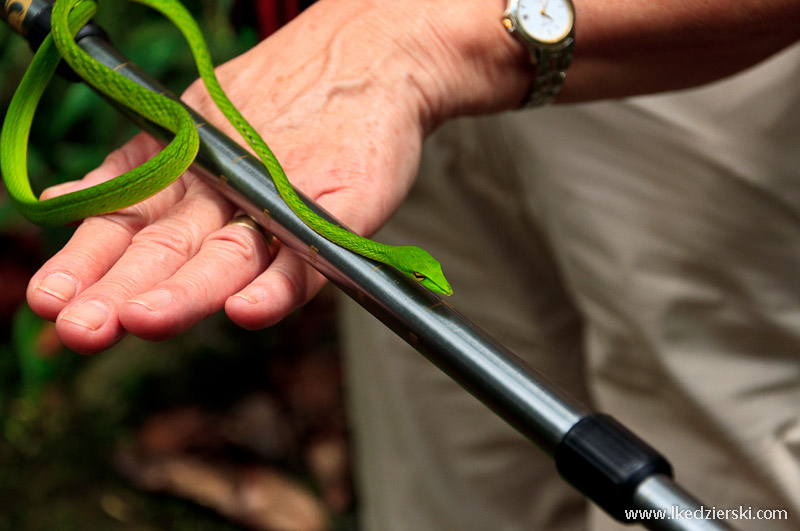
[{"x1": 28, "y1": 0, "x2": 524, "y2": 353}]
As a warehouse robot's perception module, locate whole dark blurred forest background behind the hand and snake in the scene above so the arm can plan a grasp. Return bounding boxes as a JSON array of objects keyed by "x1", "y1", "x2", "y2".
[{"x1": 0, "y1": 0, "x2": 355, "y2": 531}]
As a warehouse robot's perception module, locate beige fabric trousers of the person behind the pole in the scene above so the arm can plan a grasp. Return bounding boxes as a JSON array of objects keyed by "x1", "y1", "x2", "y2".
[{"x1": 342, "y1": 42, "x2": 800, "y2": 531}]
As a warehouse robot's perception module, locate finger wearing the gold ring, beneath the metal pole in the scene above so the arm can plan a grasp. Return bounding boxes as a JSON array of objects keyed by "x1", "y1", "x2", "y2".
[{"x1": 120, "y1": 216, "x2": 279, "y2": 341}]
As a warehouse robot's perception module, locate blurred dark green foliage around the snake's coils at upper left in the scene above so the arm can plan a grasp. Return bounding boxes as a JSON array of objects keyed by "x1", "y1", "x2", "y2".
[{"x1": 0, "y1": 0, "x2": 256, "y2": 216}]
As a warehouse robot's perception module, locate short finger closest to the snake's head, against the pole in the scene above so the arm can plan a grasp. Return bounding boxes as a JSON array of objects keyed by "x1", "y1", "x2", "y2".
[{"x1": 225, "y1": 240, "x2": 326, "y2": 330}]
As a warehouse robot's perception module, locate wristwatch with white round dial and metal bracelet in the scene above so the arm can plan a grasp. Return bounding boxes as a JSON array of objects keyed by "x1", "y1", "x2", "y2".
[{"x1": 503, "y1": 0, "x2": 575, "y2": 107}]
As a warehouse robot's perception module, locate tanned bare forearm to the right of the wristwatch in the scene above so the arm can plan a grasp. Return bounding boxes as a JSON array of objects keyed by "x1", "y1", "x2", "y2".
[{"x1": 559, "y1": 0, "x2": 800, "y2": 102}]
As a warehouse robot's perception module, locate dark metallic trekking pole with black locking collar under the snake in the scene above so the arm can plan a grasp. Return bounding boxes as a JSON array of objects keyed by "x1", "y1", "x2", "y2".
[{"x1": 0, "y1": 0, "x2": 731, "y2": 531}]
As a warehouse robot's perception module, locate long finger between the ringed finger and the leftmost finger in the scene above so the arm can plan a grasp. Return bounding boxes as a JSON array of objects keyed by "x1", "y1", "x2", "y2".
[{"x1": 50, "y1": 177, "x2": 233, "y2": 353}]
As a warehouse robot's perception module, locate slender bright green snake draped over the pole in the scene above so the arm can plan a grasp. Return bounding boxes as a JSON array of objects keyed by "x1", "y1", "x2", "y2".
[{"x1": 0, "y1": 0, "x2": 452, "y2": 295}]
